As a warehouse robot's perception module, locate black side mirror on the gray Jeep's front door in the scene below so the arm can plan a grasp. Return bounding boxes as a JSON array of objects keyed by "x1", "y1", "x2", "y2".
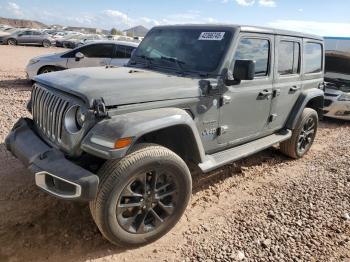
[{"x1": 224, "y1": 60, "x2": 255, "y2": 86}]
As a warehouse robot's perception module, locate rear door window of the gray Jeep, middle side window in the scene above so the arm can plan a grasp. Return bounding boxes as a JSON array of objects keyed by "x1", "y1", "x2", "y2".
[{"x1": 278, "y1": 41, "x2": 300, "y2": 75}]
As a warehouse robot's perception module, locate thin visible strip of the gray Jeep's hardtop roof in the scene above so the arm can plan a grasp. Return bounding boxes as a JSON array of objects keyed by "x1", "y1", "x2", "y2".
[{"x1": 154, "y1": 24, "x2": 323, "y2": 41}]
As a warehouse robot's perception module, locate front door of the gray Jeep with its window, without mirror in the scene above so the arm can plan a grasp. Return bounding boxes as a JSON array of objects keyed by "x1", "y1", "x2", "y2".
[{"x1": 219, "y1": 34, "x2": 274, "y2": 146}]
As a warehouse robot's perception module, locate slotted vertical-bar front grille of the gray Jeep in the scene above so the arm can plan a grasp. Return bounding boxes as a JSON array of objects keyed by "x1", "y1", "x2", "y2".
[{"x1": 32, "y1": 85, "x2": 69, "y2": 142}]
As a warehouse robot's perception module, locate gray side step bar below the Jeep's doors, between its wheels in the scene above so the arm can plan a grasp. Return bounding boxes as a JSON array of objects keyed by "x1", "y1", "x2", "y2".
[{"x1": 199, "y1": 130, "x2": 292, "y2": 173}]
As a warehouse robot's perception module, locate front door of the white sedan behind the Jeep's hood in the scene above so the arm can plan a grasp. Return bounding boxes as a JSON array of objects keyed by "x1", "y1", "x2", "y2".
[{"x1": 67, "y1": 43, "x2": 114, "y2": 68}]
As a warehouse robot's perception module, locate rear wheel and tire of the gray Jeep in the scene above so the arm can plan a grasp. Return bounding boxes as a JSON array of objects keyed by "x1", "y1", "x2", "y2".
[{"x1": 280, "y1": 108, "x2": 318, "y2": 159}]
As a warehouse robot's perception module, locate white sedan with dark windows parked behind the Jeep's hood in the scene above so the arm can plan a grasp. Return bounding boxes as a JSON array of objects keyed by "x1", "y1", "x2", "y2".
[{"x1": 26, "y1": 41, "x2": 138, "y2": 80}]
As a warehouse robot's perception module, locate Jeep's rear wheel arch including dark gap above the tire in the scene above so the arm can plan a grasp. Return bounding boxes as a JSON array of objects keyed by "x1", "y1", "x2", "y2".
[{"x1": 286, "y1": 88, "x2": 324, "y2": 130}]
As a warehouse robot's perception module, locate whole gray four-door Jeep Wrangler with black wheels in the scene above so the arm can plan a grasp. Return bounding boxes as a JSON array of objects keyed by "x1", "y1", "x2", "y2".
[{"x1": 6, "y1": 25, "x2": 324, "y2": 246}]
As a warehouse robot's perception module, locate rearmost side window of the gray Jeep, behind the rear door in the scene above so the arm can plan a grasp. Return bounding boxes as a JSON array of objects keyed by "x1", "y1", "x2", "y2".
[{"x1": 304, "y1": 43, "x2": 322, "y2": 74}]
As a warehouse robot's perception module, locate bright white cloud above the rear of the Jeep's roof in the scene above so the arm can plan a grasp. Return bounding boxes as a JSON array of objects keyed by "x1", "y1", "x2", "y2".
[{"x1": 267, "y1": 20, "x2": 350, "y2": 37}]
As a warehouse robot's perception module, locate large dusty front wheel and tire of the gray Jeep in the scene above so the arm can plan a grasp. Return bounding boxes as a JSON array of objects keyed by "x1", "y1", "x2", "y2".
[{"x1": 90, "y1": 144, "x2": 192, "y2": 247}]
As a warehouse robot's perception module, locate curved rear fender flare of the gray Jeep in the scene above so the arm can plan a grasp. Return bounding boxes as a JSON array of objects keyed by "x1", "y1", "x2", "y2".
[{"x1": 286, "y1": 88, "x2": 324, "y2": 130}]
